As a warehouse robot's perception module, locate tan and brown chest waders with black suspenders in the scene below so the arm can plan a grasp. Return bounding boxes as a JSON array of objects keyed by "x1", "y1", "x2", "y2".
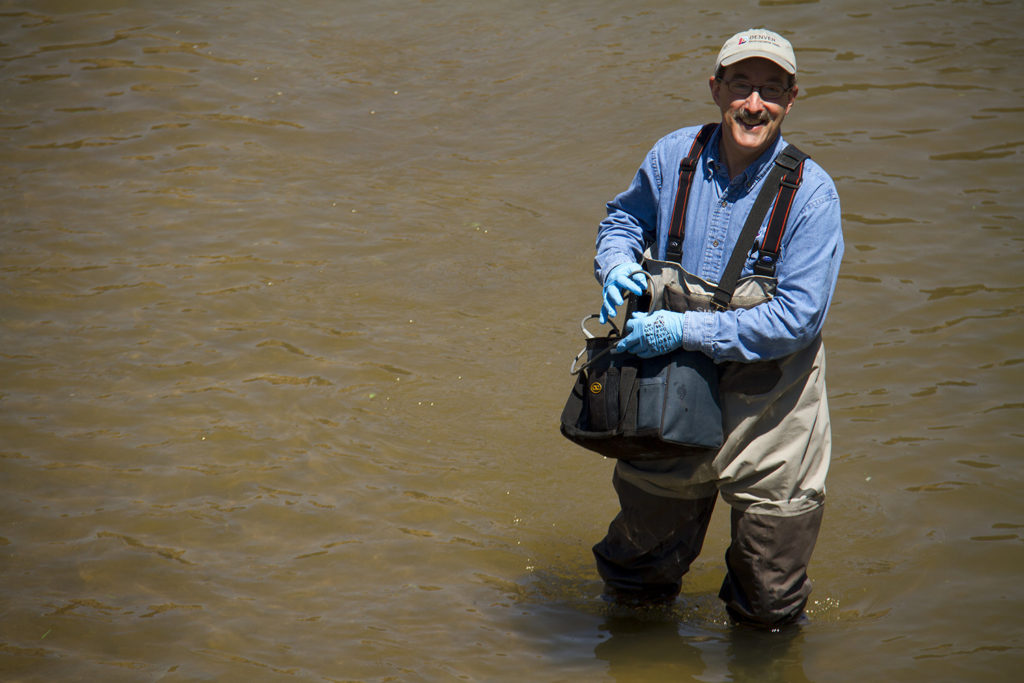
[{"x1": 594, "y1": 124, "x2": 831, "y2": 626}]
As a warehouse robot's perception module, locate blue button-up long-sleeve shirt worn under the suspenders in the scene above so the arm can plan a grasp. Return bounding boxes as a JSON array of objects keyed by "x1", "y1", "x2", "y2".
[{"x1": 594, "y1": 126, "x2": 843, "y2": 361}]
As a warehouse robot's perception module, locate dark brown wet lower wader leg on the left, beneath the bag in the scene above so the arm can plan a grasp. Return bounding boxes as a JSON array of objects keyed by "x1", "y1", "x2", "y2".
[{"x1": 594, "y1": 472, "x2": 717, "y2": 600}]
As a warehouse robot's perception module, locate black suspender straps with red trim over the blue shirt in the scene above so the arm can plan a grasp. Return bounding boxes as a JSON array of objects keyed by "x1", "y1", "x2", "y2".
[{"x1": 665, "y1": 123, "x2": 808, "y2": 310}]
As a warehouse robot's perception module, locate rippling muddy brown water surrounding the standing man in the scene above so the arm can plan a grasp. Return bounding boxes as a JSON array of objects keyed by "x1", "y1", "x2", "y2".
[{"x1": 0, "y1": 0, "x2": 1024, "y2": 682}]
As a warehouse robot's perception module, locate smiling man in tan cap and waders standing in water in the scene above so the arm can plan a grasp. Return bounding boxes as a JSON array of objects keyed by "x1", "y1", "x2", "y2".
[{"x1": 594, "y1": 29, "x2": 843, "y2": 628}]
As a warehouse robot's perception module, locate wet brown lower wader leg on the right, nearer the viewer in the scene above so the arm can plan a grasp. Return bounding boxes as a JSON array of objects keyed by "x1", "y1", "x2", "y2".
[{"x1": 719, "y1": 507, "x2": 824, "y2": 627}]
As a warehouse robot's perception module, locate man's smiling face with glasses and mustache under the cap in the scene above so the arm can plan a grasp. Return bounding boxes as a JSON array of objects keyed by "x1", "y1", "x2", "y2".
[{"x1": 711, "y1": 57, "x2": 798, "y2": 161}]
